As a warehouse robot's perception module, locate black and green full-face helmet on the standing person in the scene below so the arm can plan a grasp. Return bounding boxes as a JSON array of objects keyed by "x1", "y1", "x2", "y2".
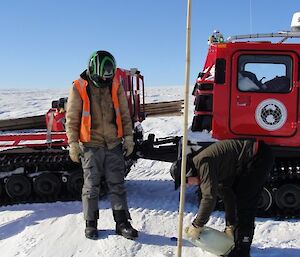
[{"x1": 87, "y1": 51, "x2": 116, "y2": 87}]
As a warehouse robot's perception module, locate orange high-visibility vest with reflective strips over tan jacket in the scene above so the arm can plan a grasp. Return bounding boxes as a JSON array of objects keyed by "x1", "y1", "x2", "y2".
[{"x1": 73, "y1": 69, "x2": 123, "y2": 142}]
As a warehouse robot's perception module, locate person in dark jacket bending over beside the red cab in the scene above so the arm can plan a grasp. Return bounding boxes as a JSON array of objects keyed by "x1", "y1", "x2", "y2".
[{"x1": 171, "y1": 139, "x2": 274, "y2": 257}]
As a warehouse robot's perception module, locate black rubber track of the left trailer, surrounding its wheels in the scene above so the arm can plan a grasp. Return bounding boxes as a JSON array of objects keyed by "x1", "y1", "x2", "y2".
[{"x1": 0, "y1": 150, "x2": 81, "y2": 205}]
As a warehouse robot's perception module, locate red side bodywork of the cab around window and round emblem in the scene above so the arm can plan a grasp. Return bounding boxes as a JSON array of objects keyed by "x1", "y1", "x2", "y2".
[{"x1": 206, "y1": 42, "x2": 300, "y2": 147}]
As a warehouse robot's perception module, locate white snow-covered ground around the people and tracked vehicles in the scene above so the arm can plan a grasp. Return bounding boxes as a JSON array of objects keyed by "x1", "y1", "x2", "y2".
[{"x1": 0, "y1": 87, "x2": 300, "y2": 257}]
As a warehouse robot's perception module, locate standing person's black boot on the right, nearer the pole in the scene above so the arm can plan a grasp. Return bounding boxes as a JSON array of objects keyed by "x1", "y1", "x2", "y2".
[{"x1": 113, "y1": 210, "x2": 138, "y2": 240}]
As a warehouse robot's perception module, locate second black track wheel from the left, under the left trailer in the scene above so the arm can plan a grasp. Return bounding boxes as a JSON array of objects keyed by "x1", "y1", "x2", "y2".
[{"x1": 33, "y1": 173, "x2": 61, "y2": 198}]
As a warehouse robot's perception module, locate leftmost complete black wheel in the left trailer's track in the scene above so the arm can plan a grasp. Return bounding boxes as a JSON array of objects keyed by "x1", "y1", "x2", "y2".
[{"x1": 5, "y1": 175, "x2": 31, "y2": 200}]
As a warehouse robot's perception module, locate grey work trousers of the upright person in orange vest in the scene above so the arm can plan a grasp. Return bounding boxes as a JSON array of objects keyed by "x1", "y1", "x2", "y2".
[{"x1": 81, "y1": 144, "x2": 128, "y2": 220}]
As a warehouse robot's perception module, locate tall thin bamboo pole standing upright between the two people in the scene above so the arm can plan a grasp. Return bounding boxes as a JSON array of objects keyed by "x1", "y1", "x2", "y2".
[{"x1": 177, "y1": 0, "x2": 192, "y2": 257}]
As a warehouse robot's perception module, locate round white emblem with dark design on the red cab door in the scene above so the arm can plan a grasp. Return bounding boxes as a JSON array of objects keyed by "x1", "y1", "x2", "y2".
[{"x1": 255, "y1": 99, "x2": 287, "y2": 131}]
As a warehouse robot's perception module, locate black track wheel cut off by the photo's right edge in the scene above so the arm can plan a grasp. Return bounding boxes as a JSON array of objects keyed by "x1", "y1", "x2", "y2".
[{"x1": 275, "y1": 184, "x2": 300, "y2": 210}]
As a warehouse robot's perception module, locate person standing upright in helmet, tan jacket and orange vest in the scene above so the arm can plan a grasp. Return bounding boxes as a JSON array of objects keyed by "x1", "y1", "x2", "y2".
[{"x1": 66, "y1": 51, "x2": 138, "y2": 239}]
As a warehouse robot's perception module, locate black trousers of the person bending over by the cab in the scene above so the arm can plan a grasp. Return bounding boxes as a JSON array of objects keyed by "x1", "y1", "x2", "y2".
[{"x1": 233, "y1": 142, "x2": 274, "y2": 256}]
